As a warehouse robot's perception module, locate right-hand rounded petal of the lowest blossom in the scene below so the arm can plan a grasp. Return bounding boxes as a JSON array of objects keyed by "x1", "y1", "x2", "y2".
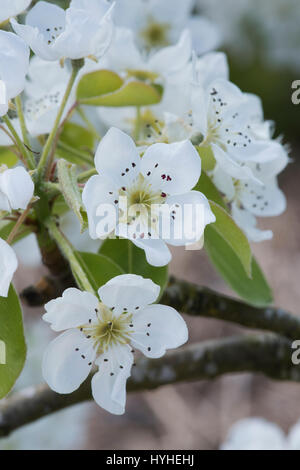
[{"x1": 131, "y1": 305, "x2": 188, "y2": 358}]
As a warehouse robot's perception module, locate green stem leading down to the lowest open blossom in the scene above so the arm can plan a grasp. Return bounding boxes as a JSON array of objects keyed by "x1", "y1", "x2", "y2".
[{"x1": 46, "y1": 218, "x2": 95, "y2": 294}]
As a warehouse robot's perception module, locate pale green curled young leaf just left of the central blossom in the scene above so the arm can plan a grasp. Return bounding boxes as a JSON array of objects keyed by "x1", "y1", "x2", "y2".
[{"x1": 57, "y1": 159, "x2": 88, "y2": 233}]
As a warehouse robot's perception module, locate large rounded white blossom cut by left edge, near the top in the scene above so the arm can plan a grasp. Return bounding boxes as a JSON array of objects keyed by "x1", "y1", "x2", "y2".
[{"x1": 0, "y1": 30, "x2": 29, "y2": 116}]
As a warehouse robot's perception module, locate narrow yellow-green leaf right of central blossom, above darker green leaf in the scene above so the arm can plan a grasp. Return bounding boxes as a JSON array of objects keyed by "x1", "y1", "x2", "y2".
[{"x1": 209, "y1": 201, "x2": 252, "y2": 277}]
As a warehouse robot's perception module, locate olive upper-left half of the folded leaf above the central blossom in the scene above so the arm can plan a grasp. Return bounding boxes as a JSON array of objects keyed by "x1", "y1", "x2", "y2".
[{"x1": 77, "y1": 70, "x2": 123, "y2": 101}]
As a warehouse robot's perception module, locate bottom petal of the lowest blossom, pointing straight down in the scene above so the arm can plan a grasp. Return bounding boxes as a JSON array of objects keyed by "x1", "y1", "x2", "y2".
[{"x1": 92, "y1": 345, "x2": 133, "y2": 415}]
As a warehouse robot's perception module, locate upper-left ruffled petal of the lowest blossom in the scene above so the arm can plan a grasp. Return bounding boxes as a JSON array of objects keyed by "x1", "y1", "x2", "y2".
[{"x1": 43, "y1": 288, "x2": 98, "y2": 331}]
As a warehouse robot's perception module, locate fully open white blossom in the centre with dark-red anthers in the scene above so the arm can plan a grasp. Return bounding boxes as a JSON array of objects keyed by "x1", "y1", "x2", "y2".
[{"x1": 83, "y1": 128, "x2": 215, "y2": 266}]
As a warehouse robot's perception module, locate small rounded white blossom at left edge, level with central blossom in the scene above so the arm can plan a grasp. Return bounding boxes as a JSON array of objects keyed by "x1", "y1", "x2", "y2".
[{"x1": 0, "y1": 165, "x2": 34, "y2": 212}]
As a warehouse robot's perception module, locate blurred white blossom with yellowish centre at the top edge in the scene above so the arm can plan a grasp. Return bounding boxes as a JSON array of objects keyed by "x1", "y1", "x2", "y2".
[{"x1": 114, "y1": 0, "x2": 221, "y2": 54}]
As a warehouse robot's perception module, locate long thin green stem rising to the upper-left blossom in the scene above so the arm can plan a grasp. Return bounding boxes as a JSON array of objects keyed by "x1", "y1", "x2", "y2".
[{"x1": 37, "y1": 61, "x2": 80, "y2": 177}]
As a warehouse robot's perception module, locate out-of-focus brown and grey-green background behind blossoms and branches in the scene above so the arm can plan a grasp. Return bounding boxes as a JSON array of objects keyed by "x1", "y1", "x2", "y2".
[{"x1": 0, "y1": 0, "x2": 300, "y2": 449}]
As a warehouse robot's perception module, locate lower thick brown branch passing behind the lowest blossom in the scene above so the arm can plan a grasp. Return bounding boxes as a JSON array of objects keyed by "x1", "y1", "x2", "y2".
[{"x1": 0, "y1": 334, "x2": 300, "y2": 437}]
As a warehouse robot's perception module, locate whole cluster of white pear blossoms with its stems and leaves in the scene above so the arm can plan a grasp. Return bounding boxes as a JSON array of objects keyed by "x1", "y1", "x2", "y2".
[{"x1": 0, "y1": 0, "x2": 288, "y2": 414}]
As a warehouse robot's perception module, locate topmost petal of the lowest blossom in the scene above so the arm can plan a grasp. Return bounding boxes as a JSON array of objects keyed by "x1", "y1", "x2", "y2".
[{"x1": 98, "y1": 274, "x2": 160, "y2": 315}]
